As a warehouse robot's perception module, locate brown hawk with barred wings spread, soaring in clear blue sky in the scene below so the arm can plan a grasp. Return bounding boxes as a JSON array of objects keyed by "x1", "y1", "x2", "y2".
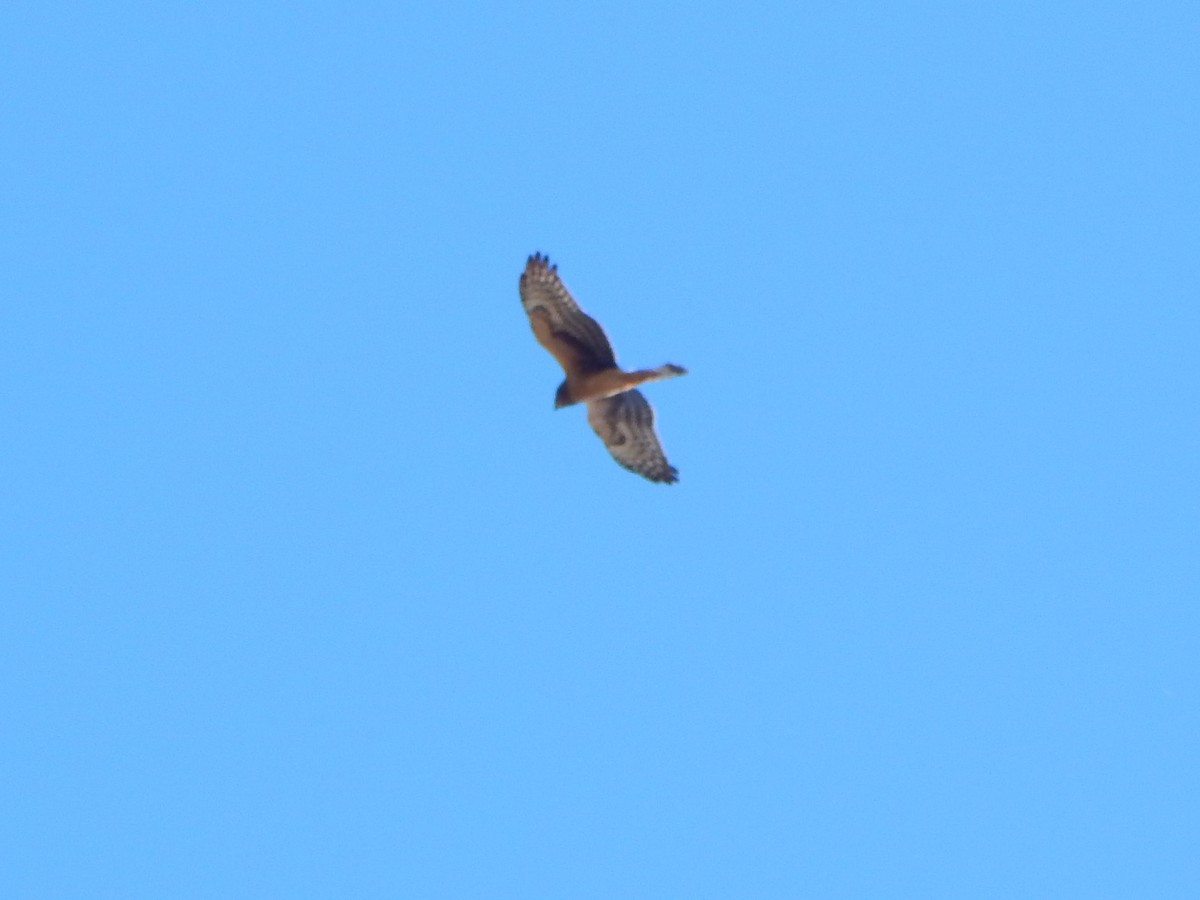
[{"x1": 521, "y1": 253, "x2": 688, "y2": 484}]
